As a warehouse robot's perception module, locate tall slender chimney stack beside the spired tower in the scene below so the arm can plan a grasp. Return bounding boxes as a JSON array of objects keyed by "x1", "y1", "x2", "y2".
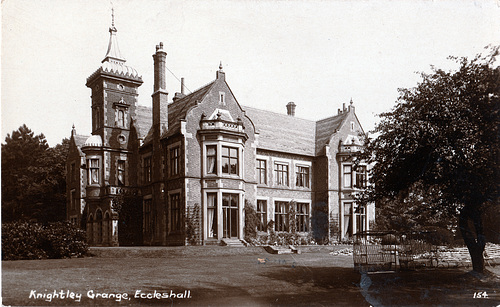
[{"x1": 151, "y1": 43, "x2": 168, "y2": 138}]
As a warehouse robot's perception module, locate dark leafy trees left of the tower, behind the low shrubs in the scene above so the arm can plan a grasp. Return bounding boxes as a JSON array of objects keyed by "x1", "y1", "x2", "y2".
[{"x1": 2, "y1": 125, "x2": 69, "y2": 222}]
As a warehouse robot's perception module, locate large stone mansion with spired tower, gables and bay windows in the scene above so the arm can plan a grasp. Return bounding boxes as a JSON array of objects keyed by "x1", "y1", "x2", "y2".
[{"x1": 67, "y1": 21, "x2": 375, "y2": 246}]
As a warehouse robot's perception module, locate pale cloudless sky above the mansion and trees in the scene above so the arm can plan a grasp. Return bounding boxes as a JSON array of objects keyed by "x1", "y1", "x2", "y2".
[{"x1": 1, "y1": 0, "x2": 500, "y2": 146}]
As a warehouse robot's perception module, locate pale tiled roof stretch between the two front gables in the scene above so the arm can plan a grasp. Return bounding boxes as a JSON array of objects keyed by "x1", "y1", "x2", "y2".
[{"x1": 242, "y1": 106, "x2": 315, "y2": 156}]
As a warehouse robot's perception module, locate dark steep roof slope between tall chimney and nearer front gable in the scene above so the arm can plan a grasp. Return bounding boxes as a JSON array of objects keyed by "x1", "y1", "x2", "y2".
[{"x1": 167, "y1": 81, "x2": 215, "y2": 136}]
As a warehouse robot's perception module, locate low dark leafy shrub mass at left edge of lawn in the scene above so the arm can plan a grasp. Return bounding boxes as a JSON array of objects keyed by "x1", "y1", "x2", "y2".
[{"x1": 2, "y1": 222, "x2": 88, "y2": 260}]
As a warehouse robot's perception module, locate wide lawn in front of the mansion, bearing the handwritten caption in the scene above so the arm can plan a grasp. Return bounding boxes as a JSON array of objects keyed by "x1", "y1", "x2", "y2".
[{"x1": 2, "y1": 247, "x2": 500, "y2": 306}]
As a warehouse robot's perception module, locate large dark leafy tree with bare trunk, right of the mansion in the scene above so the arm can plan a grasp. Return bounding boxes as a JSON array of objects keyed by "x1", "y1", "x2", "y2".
[{"x1": 359, "y1": 47, "x2": 500, "y2": 272}]
